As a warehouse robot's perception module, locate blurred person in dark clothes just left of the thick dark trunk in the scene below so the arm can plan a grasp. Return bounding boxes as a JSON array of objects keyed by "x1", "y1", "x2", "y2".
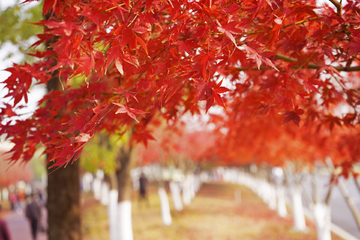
[{"x1": 25, "y1": 194, "x2": 41, "y2": 240}]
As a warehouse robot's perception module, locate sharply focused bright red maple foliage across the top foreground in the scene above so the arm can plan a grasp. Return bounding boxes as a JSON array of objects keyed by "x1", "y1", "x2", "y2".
[{"x1": 0, "y1": 0, "x2": 360, "y2": 172}]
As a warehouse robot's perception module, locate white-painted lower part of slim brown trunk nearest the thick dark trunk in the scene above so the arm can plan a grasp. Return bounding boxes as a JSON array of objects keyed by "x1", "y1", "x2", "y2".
[{"x1": 117, "y1": 201, "x2": 134, "y2": 240}]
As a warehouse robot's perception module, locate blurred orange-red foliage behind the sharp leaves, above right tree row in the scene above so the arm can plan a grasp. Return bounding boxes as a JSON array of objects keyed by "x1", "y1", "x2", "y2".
[{"x1": 211, "y1": 94, "x2": 360, "y2": 177}]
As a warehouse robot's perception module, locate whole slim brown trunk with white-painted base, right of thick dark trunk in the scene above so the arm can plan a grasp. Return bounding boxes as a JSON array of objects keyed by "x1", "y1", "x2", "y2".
[{"x1": 116, "y1": 147, "x2": 133, "y2": 240}]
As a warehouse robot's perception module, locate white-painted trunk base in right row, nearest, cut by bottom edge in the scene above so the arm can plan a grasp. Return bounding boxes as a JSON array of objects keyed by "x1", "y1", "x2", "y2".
[{"x1": 314, "y1": 203, "x2": 331, "y2": 240}]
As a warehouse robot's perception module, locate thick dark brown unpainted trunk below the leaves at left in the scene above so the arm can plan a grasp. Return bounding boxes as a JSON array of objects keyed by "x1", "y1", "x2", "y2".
[{"x1": 47, "y1": 160, "x2": 81, "y2": 240}]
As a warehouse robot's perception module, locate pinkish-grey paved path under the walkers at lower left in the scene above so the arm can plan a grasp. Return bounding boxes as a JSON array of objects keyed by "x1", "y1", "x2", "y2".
[{"x1": 4, "y1": 209, "x2": 47, "y2": 240}]
